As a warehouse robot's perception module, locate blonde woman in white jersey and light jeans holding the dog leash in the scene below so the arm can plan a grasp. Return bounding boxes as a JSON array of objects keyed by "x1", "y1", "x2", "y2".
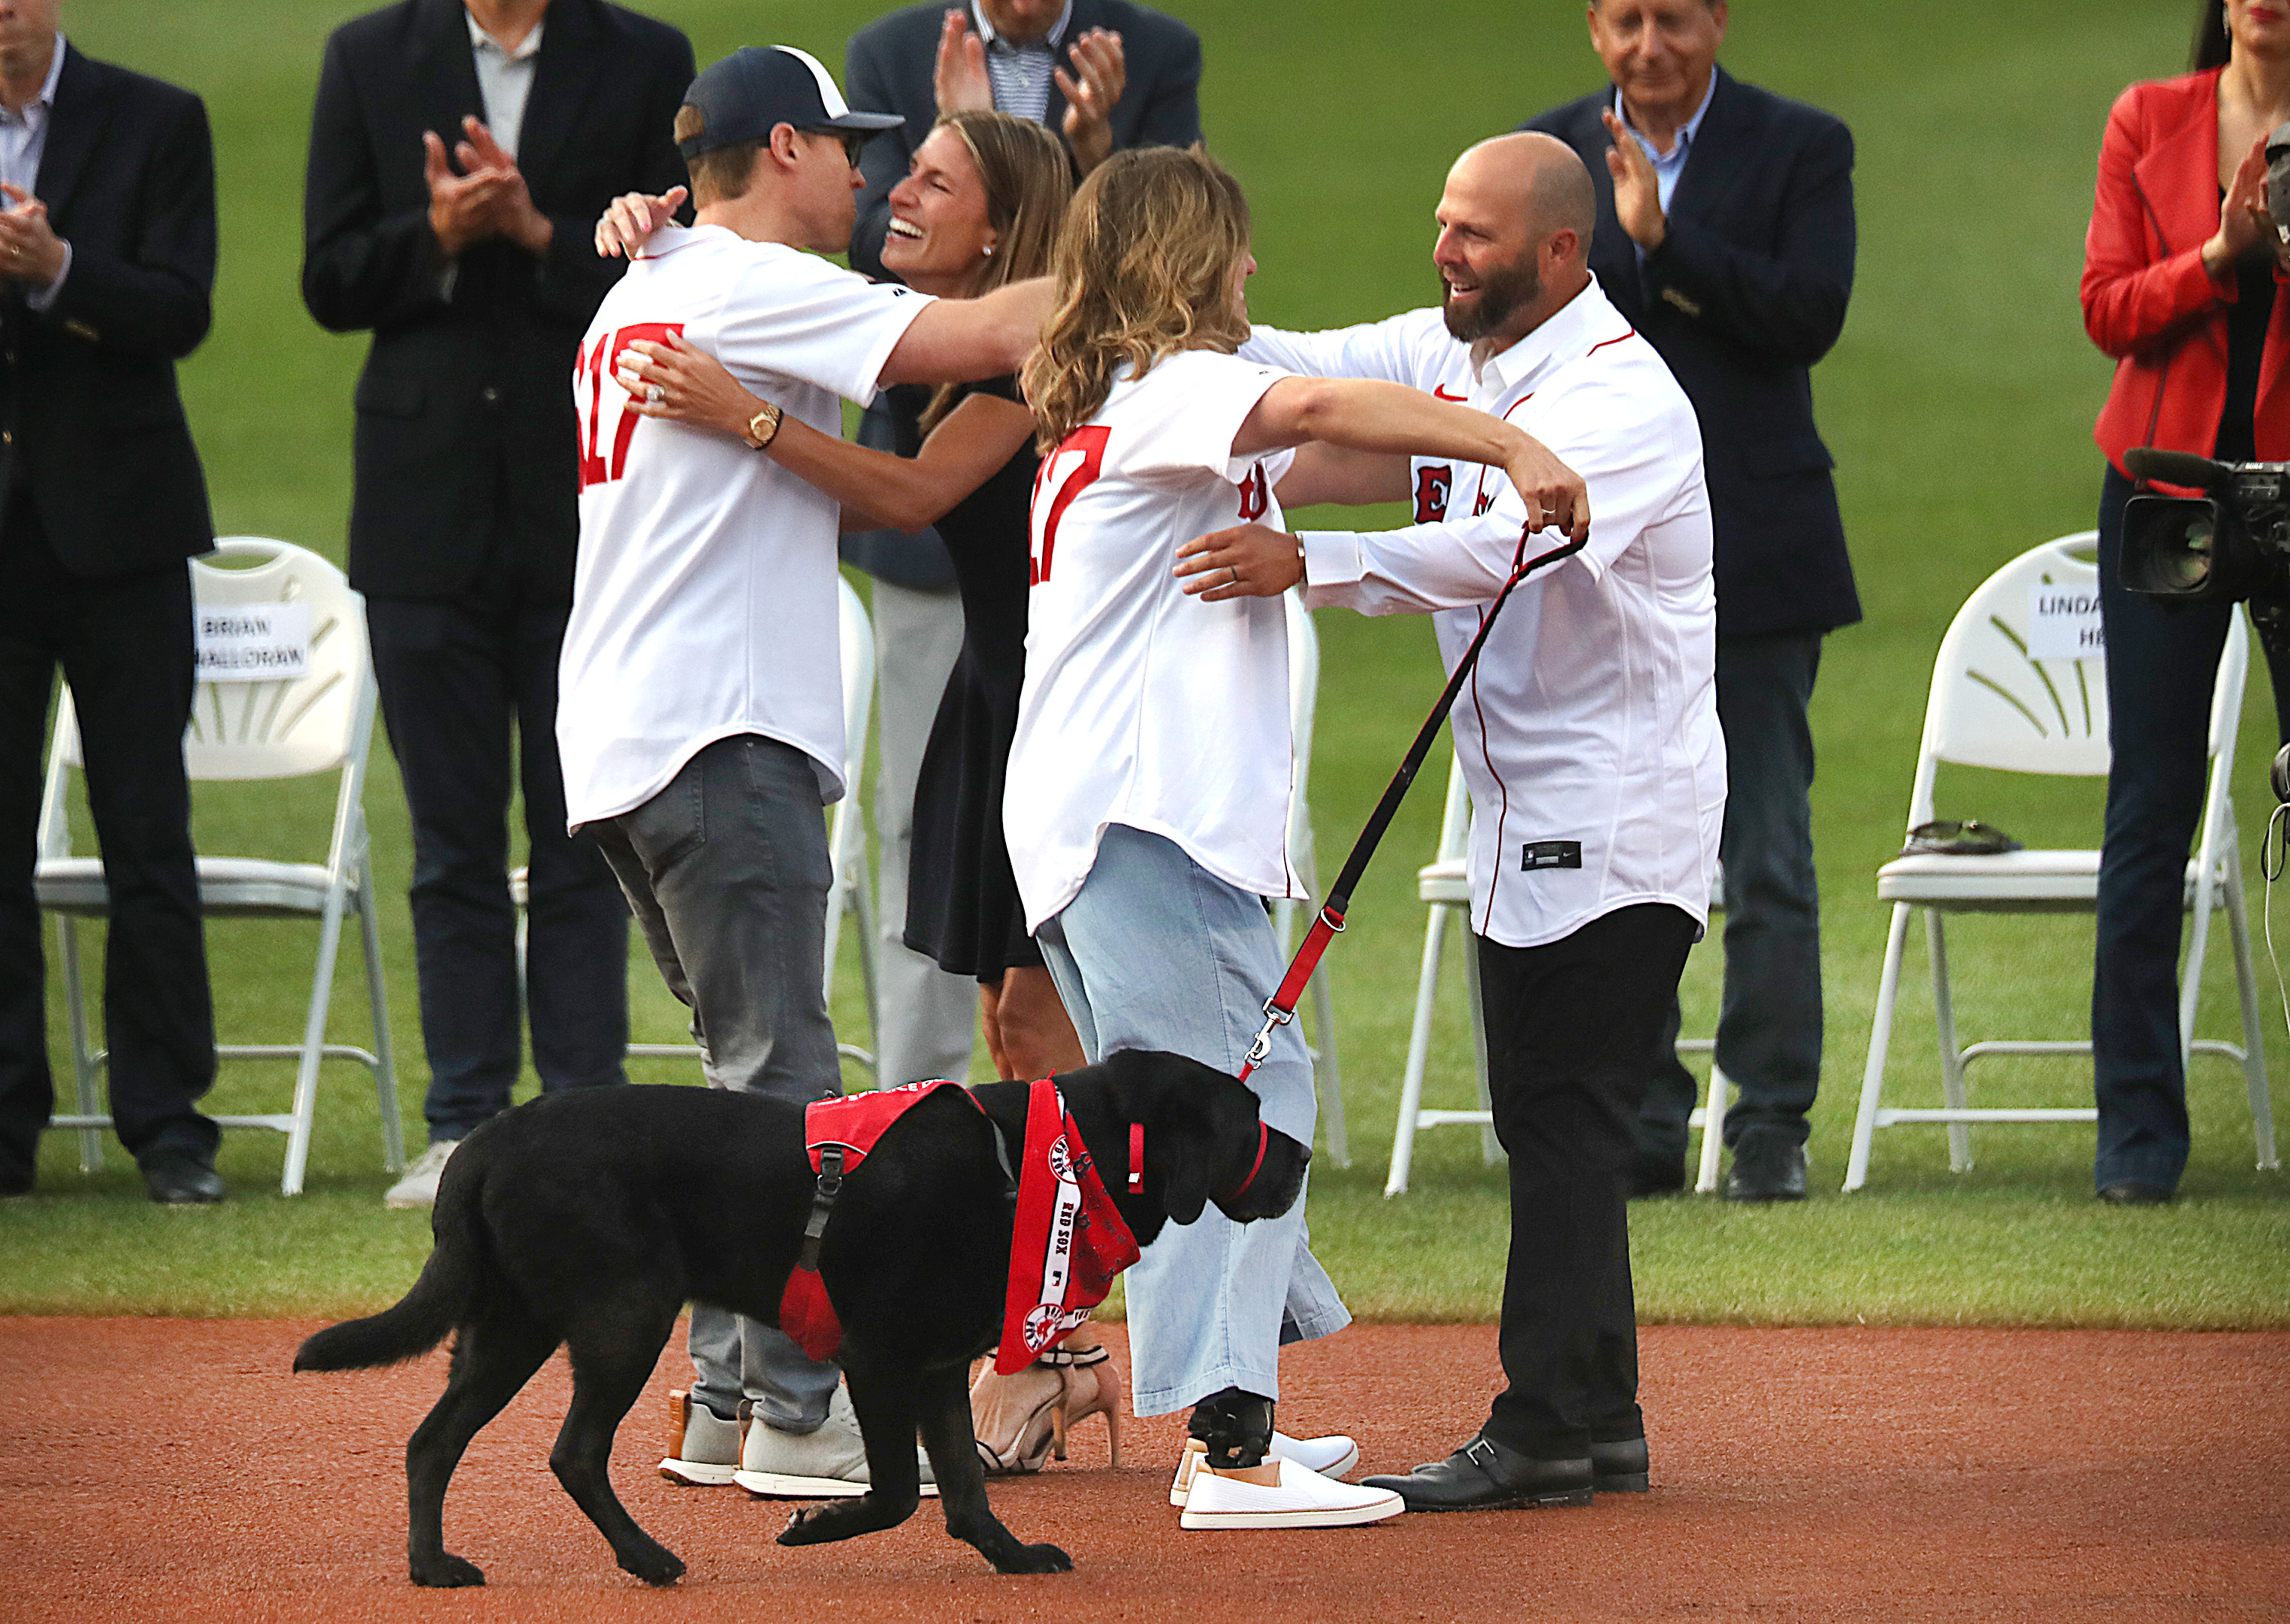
[{"x1": 1003, "y1": 149, "x2": 1589, "y2": 1528}]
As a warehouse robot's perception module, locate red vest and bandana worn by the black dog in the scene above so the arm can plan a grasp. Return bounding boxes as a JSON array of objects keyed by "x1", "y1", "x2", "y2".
[{"x1": 778, "y1": 1076, "x2": 1138, "y2": 1372}]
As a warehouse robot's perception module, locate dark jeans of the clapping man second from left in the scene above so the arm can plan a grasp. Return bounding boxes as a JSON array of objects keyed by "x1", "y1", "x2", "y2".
[{"x1": 367, "y1": 591, "x2": 627, "y2": 1141}]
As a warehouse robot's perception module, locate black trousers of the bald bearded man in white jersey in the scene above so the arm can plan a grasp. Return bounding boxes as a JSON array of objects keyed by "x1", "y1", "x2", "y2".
[{"x1": 1477, "y1": 902, "x2": 1695, "y2": 1461}]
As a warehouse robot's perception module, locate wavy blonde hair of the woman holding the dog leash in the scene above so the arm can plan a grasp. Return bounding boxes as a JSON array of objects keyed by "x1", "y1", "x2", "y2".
[{"x1": 1021, "y1": 146, "x2": 1248, "y2": 456}]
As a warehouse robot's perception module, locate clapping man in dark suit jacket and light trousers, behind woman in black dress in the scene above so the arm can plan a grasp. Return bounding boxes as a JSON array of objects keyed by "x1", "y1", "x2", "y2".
[{"x1": 843, "y1": 0, "x2": 1200, "y2": 1103}]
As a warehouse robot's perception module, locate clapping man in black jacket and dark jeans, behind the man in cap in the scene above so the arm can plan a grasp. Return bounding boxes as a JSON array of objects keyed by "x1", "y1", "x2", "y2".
[{"x1": 302, "y1": 0, "x2": 694, "y2": 1207}]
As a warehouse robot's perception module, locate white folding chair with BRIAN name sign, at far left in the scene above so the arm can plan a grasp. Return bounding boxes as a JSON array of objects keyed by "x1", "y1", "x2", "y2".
[{"x1": 35, "y1": 536, "x2": 405, "y2": 1196}]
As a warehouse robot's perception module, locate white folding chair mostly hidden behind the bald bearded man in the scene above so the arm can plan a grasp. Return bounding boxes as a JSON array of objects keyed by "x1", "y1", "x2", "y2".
[{"x1": 1383, "y1": 760, "x2": 1729, "y2": 1196}]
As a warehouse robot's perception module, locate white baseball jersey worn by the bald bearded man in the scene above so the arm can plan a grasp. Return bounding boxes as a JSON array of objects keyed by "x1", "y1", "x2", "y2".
[{"x1": 1243, "y1": 282, "x2": 1724, "y2": 948}]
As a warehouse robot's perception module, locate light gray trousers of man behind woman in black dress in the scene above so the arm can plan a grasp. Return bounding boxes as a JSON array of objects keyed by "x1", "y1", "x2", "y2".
[{"x1": 854, "y1": 579, "x2": 977, "y2": 1088}]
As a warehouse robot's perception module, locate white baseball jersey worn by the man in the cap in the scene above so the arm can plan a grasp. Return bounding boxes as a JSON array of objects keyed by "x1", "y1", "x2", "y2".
[{"x1": 557, "y1": 227, "x2": 929, "y2": 829}]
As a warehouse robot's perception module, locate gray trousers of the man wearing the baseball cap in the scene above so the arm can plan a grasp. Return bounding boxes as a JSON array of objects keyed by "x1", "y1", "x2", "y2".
[{"x1": 588, "y1": 733, "x2": 843, "y2": 1432}]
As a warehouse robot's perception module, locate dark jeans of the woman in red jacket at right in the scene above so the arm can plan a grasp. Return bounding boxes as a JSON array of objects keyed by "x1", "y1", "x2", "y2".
[{"x1": 2091, "y1": 467, "x2": 2290, "y2": 1189}]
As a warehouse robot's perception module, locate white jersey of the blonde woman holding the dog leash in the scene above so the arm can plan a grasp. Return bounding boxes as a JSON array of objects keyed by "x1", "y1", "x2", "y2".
[{"x1": 1003, "y1": 351, "x2": 1303, "y2": 930}]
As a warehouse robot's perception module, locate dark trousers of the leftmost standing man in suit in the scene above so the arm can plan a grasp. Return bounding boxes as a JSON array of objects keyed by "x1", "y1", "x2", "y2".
[{"x1": 0, "y1": 495, "x2": 220, "y2": 1173}]
